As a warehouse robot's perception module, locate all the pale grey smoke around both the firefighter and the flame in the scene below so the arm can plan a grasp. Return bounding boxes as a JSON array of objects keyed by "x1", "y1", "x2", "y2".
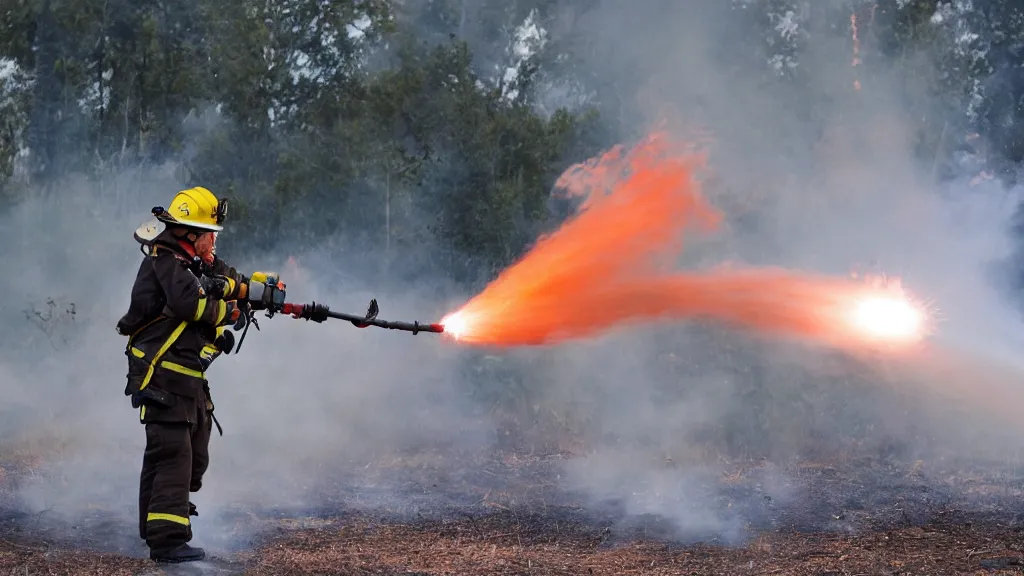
[{"x1": 0, "y1": 1, "x2": 1024, "y2": 550}]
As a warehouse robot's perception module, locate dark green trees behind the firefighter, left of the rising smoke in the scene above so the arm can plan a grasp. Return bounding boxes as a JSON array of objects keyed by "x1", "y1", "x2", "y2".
[{"x1": 0, "y1": 0, "x2": 603, "y2": 278}]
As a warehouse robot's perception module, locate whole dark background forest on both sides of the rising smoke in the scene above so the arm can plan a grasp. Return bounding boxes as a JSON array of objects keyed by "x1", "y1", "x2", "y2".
[{"x1": 0, "y1": 0, "x2": 1024, "y2": 280}]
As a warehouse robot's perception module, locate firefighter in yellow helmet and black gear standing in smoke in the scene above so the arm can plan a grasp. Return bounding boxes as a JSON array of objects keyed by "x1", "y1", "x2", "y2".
[{"x1": 117, "y1": 188, "x2": 284, "y2": 562}]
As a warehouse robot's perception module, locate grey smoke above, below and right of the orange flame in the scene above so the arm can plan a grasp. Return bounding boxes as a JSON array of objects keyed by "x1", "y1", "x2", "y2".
[{"x1": 485, "y1": 2, "x2": 1024, "y2": 535}]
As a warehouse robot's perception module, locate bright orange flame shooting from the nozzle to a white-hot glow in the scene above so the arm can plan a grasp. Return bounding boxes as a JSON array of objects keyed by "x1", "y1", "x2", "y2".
[{"x1": 441, "y1": 133, "x2": 928, "y2": 349}]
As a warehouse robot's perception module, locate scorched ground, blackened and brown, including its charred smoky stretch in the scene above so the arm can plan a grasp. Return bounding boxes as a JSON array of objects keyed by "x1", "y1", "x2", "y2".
[{"x1": 0, "y1": 448, "x2": 1024, "y2": 576}]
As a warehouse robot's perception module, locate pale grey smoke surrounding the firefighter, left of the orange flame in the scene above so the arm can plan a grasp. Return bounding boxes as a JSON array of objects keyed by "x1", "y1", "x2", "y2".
[{"x1": 0, "y1": 159, "x2": 494, "y2": 553}]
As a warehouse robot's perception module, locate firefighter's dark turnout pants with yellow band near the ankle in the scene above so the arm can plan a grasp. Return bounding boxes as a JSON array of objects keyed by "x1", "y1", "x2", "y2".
[{"x1": 138, "y1": 375, "x2": 212, "y2": 550}]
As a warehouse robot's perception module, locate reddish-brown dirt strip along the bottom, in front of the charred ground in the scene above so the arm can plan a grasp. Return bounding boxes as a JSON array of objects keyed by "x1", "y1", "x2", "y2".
[{"x1": 0, "y1": 511, "x2": 1024, "y2": 576}]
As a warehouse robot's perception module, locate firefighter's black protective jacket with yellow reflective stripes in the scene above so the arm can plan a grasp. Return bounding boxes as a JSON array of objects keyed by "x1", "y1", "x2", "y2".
[{"x1": 117, "y1": 235, "x2": 249, "y2": 421}]
